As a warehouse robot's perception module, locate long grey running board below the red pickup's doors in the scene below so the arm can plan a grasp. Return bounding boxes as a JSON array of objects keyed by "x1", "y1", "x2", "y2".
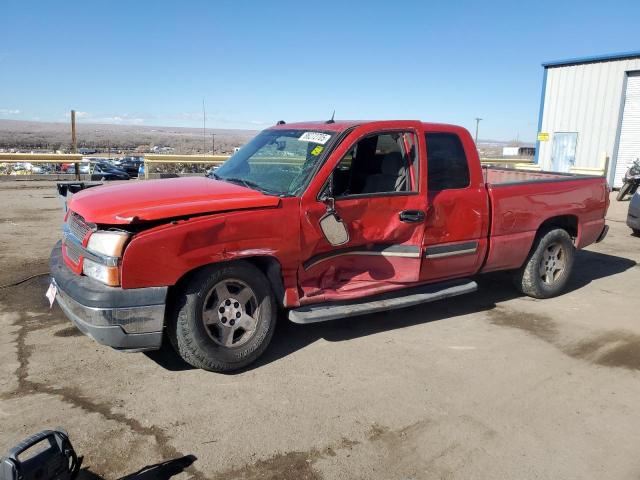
[{"x1": 289, "y1": 279, "x2": 478, "y2": 323}]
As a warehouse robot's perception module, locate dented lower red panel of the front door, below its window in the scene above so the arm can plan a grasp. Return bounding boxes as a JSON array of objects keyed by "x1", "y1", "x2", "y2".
[{"x1": 299, "y1": 194, "x2": 425, "y2": 297}]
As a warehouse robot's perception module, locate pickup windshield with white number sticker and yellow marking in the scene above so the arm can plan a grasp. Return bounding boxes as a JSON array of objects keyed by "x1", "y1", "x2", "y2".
[{"x1": 211, "y1": 129, "x2": 335, "y2": 195}]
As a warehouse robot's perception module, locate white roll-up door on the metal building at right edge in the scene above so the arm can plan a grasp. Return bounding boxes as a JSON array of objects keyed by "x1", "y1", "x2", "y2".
[{"x1": 613, "y1": 74, "x2": 640, "y2": 187}]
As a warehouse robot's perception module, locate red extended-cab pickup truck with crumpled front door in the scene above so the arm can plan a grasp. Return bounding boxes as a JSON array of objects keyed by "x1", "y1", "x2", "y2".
[{"x1": 50, "y1": 121, "x2": 609, "y2": 371}]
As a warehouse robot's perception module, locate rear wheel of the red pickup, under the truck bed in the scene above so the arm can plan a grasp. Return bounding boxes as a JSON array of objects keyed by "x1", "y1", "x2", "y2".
[{"x1": 514, "y1": 227, "x2": 575, "y2": 298}]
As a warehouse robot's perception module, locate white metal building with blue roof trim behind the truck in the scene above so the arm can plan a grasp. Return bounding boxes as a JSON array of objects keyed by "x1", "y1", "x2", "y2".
[{"x1": 535, "y1": 51, "x2": 640, "y2": 188}]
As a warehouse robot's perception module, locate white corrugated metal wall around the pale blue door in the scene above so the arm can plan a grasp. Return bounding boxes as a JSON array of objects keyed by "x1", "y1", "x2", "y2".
[{"x1": 538, "y1": 58, "x2": 640, "y2": 184}]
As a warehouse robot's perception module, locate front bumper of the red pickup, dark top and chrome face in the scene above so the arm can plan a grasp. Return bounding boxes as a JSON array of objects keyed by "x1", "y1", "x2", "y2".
[{"x1": 49, "y1": 242, "x2": 167, "y2": 351}]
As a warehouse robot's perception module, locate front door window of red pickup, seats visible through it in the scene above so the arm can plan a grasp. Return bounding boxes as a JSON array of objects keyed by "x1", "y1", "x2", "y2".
[{"x1": 333, "y1": 132, "x2": 418, "y2": 198}]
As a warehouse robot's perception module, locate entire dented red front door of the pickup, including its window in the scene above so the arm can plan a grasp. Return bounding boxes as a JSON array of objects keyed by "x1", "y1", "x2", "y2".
[{"x1": 298, "y1": 122, "x2": 426, "y2": 303}]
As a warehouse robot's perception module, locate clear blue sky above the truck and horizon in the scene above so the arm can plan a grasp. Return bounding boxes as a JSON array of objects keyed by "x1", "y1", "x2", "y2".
[{"x1": 0, "y1": 0, "x2": 640, "y2": 141}]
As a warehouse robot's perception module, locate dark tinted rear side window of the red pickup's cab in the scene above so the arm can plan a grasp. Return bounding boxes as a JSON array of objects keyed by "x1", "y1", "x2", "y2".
[{"x1": 425, "y1": 133, "x2": 469, "y2": 191}]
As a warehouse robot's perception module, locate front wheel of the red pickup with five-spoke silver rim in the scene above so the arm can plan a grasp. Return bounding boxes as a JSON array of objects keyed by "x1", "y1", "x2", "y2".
[{"x1": 169, "y1": 262, "x2": 277, "y2": 372}]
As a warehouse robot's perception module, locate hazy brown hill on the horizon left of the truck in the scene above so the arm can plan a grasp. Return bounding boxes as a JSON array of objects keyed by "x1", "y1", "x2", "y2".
[{"x1": 0, "y1": 120, "x2": 257, "y2": 153}]
